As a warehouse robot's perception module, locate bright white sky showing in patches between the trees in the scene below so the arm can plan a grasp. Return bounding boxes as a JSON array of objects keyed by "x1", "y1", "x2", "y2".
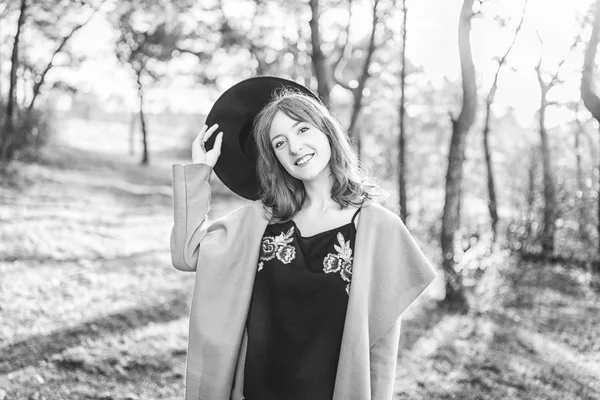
[{"x1": 12, "y1": 0, "x2": 591, "y2": 126}]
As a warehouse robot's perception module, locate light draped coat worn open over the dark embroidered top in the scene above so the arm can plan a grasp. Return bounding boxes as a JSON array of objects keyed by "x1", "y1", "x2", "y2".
[{"x1": 171, "y1": 164, "x2": 436, "y2": 400}]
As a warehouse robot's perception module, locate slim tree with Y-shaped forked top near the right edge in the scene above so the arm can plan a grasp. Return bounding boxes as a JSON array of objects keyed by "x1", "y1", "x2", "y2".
[{"x1": 535, "y1": 34, "x2": 579, "y2": 257}]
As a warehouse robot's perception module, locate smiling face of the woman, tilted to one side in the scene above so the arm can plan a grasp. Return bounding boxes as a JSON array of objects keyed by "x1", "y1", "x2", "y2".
[{"x1": 269, "y1": 111, "x2": 331, "y2": 182}]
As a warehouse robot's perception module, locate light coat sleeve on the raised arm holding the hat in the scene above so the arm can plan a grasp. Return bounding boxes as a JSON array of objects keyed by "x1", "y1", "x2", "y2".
[{"x1": 171, "y1": 164, "x2": 212, "y2": 271}]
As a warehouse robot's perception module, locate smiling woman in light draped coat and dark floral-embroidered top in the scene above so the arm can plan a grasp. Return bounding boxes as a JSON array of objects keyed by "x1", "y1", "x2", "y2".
[{"x1": 171, "y1": 77, "x2": 435, "y2": 400}]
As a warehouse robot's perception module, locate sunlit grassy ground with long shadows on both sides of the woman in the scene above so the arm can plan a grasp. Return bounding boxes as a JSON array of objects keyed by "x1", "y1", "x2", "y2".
[{"x1": 0, "y1": 120, "x2": 600, "y2": 400}]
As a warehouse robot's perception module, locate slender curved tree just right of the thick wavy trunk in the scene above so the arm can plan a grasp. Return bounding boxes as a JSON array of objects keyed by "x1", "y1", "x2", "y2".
[{"x1": 483, "y1": 0, "x2": 527, "y2": 242}]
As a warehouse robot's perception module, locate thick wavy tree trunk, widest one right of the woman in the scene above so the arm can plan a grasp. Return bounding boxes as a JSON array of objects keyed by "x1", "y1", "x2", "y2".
[{"x1": 441, "y1": 0, "x2": 477, "y2": 308}]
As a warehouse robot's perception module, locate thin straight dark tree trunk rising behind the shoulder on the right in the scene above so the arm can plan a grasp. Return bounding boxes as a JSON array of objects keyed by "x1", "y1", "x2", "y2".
[{"x1": 398, "y1": 0, "x2": 408, "y2": 223}]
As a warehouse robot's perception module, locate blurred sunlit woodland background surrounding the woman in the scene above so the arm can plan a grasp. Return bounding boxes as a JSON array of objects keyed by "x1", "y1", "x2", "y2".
[{"x1": 0, "y1": 0, "x2": 600, "y2": 400}]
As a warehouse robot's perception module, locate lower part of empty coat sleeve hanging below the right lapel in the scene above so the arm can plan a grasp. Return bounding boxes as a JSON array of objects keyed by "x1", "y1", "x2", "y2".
[{"x1": 370, "y1": 318, "x2": 402, "y2": 400}]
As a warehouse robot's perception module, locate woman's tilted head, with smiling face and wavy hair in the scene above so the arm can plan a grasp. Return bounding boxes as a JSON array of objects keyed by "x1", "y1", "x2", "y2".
[{"x1": 254, "y1": 90, "x2": 378, "y2": 223}]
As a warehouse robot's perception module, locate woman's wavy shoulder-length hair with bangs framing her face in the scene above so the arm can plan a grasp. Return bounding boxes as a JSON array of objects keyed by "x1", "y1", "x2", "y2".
[{"x1": 254, "y1": 89, "x2": 381, "y2": 221}]
